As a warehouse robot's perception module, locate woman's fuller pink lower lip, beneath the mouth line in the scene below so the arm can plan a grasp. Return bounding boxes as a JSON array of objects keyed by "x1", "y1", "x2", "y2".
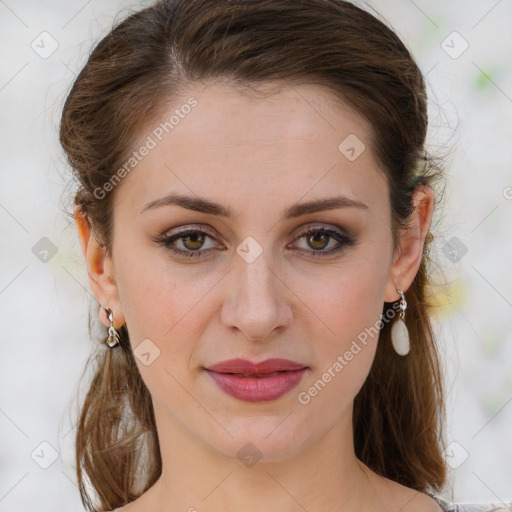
[{"x1": 206, "y1": 368, "x2": 307, "y2": 402}]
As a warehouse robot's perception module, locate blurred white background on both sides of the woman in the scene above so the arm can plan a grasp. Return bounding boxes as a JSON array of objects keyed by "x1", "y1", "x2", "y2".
[{"x1": 0, "y1": 0, "x2": 512, "y2": 512}]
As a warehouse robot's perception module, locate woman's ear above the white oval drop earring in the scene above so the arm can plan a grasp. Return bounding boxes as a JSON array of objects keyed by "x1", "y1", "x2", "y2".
[{"x1": 384, "y1": 185, "x2": 435, "y2": 302}]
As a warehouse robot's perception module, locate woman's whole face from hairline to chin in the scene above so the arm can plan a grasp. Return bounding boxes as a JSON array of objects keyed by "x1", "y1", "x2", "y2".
[{"x1": 92, "y1": 83, "x2": 412, "y2": 460}]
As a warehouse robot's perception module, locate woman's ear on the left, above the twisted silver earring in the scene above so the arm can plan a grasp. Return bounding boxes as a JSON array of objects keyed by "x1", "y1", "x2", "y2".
[{"x1": 74, "y1": 206, "x2": 125, "y2": 328}]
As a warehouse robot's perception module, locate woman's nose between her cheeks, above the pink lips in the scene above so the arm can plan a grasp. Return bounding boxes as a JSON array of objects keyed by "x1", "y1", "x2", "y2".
[{"x1": 222, "y1": 246, "x2": 293, "y2": 341}]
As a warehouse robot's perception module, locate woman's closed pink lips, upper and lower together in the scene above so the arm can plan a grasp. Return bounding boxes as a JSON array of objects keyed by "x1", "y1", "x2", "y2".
[{"x1": 206, "y1": 359, "x2": 307, "y2": 402}]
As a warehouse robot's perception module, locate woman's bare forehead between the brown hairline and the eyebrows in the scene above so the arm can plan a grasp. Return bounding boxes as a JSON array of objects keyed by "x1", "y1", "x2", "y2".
[{"x1": 112, "y1": 83, "x2": 386, "y2": 221}]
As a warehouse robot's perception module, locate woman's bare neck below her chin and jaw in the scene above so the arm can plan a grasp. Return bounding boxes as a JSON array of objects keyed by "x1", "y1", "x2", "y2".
[{"x1": 141, "y1": 410, "x2": 379, "y2": 512}]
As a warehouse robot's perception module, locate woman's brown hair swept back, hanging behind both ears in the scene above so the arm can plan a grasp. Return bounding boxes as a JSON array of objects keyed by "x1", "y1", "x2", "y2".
[{"x1": 60, "y1": 0, "x2": 446, "y2": 511}]
